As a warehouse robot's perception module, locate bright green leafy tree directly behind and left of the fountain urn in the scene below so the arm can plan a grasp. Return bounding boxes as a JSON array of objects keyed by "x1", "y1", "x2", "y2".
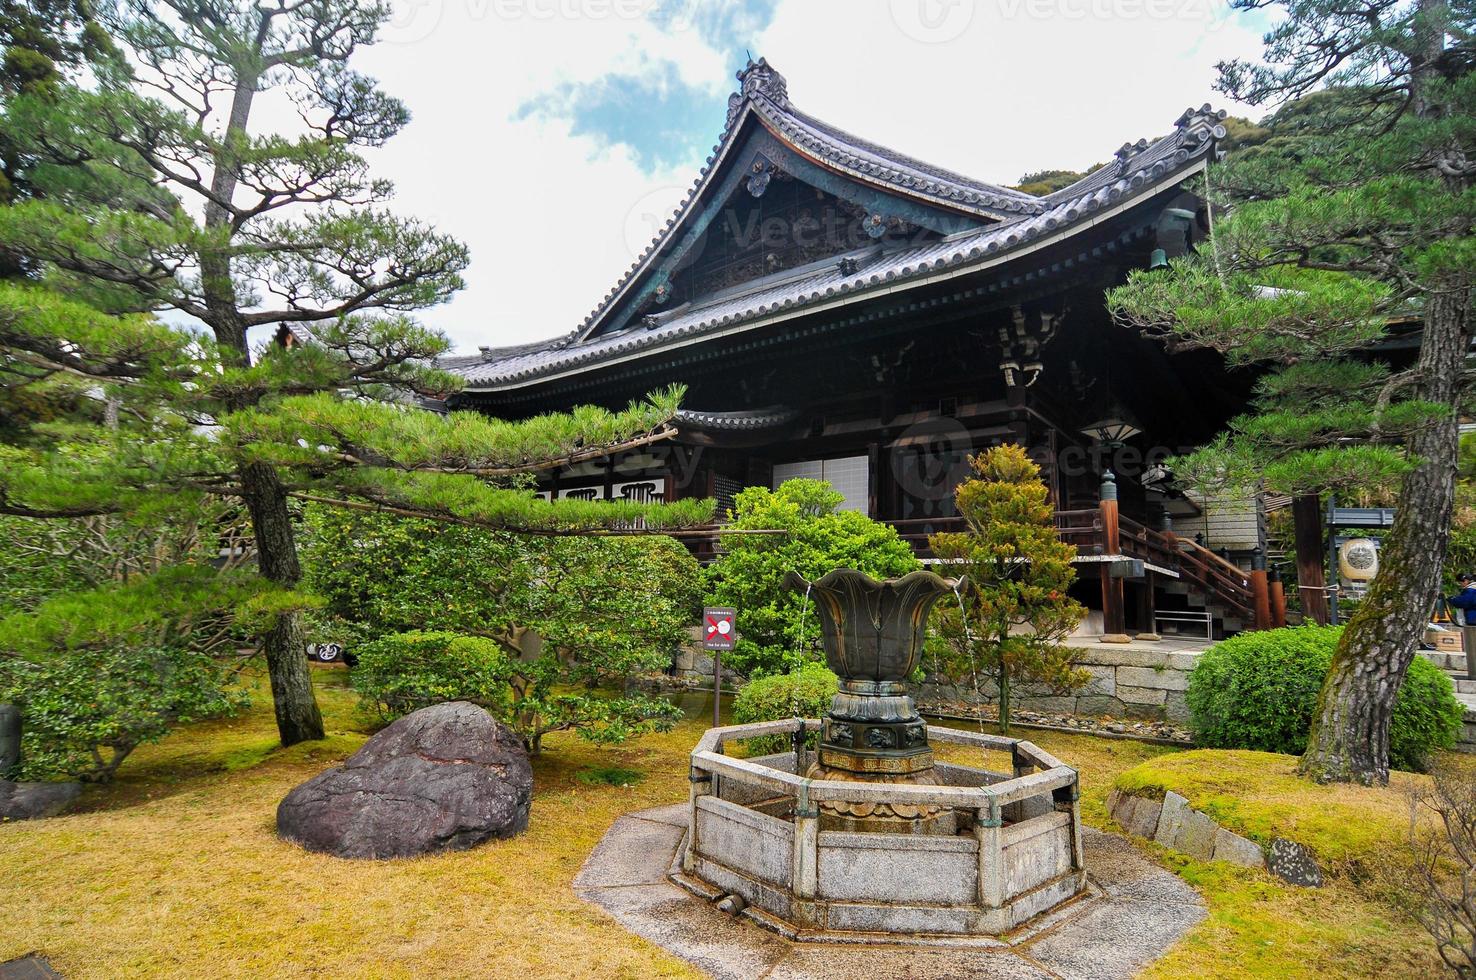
[{"x1": 707, "y1": 480, "x2": 920, "y2": 673}]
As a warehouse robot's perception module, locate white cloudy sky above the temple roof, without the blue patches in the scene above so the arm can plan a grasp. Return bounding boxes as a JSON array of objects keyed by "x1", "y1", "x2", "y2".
[{"x1": 356, "y1": 0, "x2": 1262, "y2": 353}]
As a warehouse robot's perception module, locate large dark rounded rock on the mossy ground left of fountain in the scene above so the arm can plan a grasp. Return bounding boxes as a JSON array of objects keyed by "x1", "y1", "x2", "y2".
[{"x1": 277, "y1": 701, "x2": 533, "y2": 858}]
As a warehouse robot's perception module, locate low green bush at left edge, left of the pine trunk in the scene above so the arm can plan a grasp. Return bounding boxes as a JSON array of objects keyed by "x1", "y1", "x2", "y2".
[{"x1": 0, "y1": 646, "x2": 246, "y2": 782}]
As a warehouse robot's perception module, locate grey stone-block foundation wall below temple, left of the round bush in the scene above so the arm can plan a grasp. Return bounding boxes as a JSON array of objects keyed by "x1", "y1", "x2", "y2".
[{"x1": 915, "y1": 643, "x2": 1199, "y2": 723}]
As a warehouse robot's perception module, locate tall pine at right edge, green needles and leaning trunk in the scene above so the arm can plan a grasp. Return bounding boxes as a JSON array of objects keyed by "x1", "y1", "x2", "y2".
[{"x1": 1110, "y1": 0, "x2": 1476, "y2": 784}]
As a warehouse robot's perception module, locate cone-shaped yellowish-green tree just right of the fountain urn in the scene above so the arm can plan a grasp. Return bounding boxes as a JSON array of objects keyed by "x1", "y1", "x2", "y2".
[{"x1": 928, "y1": 444, "x2": 1088, "y2": 734}]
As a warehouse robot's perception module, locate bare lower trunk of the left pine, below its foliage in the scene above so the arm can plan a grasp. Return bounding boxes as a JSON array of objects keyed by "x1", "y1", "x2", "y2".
[{"x1": 241, "y1": 463, "x2": 323, "y2": 745}]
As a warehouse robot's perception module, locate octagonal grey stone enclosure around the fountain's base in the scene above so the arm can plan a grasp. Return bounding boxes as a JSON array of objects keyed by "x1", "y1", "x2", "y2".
[{"x1": 672, "y1": 719, "x2": 1086, "y2": 937}]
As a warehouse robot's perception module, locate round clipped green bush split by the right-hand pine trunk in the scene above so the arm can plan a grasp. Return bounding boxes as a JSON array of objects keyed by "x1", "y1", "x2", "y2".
[{"x1": 1187, "y1": 626, "x2": 1464, "y2": 772}]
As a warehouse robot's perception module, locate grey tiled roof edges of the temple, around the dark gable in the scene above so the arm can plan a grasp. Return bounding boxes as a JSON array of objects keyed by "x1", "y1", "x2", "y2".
[{"x1": 453, "y1": 61, "x2": 1225, "y2": 391}]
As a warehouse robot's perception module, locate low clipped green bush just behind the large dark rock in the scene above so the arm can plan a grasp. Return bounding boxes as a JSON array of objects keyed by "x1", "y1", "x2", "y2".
[{"x1": 350, "y1": 630, "x2": 512, "y2": 719}]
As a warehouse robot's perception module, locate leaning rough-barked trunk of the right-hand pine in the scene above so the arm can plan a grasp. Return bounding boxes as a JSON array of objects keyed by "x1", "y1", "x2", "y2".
[{"x1": 1300, "y1": 289, "x2": 1470, "y2": 785}]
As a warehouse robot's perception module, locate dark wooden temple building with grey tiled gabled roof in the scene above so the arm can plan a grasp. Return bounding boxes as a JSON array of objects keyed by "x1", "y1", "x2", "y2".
[{"x1": 443, "y1": 59, "x2": 1280, "y2": 636}]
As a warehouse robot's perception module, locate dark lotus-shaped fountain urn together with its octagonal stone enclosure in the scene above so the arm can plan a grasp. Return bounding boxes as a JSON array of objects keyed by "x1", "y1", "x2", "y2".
[{"x1": 673, "y1": 570, "x2": 1086, "y2": 942}]
